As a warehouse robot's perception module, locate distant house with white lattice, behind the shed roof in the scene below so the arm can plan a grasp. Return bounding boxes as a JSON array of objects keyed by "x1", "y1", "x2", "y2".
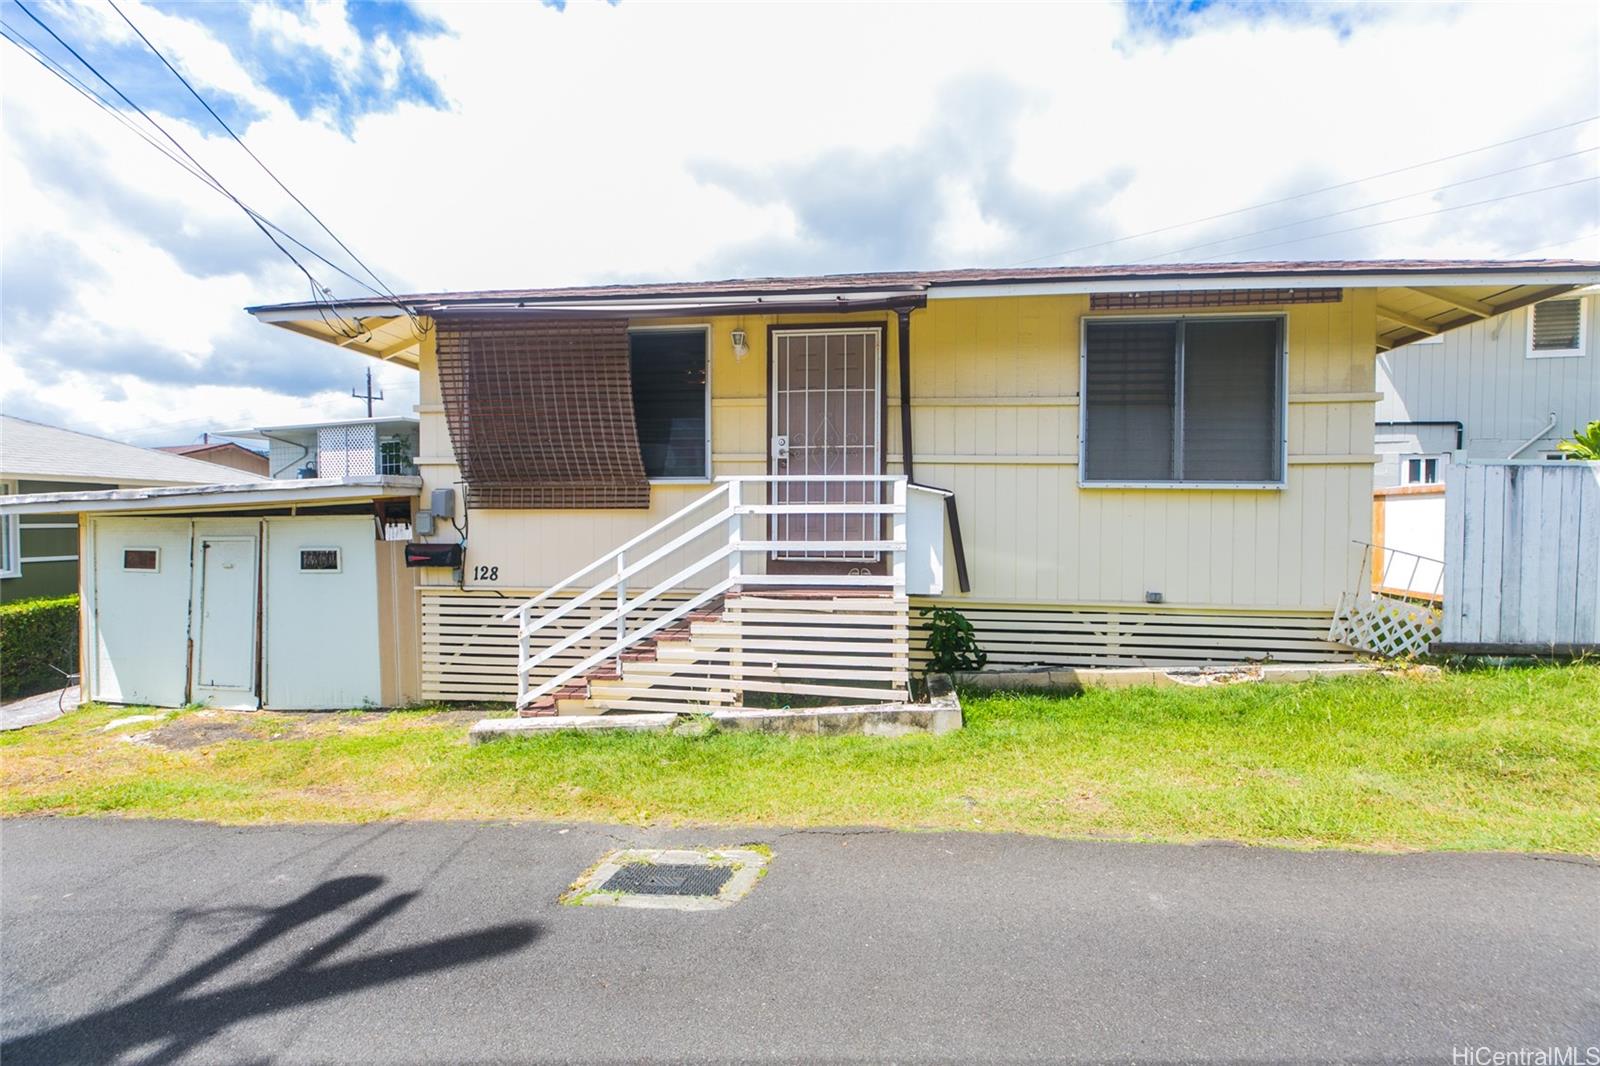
[{"x1": 216, "y1": 416, "x2": 418, "y2": 479}]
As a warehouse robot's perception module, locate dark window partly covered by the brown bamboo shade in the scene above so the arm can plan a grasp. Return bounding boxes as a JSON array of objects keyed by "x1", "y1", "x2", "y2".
[{"x1": 629, "y1": 328, "x2": 710, "y2": 480}]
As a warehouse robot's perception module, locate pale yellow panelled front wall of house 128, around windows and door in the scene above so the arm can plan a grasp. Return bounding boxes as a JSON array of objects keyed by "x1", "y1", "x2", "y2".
[{"x1": 419, "y1": 290, "x2": 1376, "y2": 610}]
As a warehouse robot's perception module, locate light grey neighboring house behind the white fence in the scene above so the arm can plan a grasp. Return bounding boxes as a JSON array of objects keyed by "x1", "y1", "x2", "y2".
[{"x1": 1376, "y1": 290, "x2": 1600, "y2": 488}]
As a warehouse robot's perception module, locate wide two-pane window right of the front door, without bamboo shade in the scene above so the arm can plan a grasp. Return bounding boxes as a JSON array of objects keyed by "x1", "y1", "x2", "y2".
[{"x1": 1082, "y1": 315, "x2": 1286, "y2": 488}]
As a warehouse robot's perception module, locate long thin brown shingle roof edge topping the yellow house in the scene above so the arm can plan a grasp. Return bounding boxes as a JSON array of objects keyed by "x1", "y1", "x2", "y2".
[{"x1": 245, "y1": 259, "x2": 1600, "y2": 314}]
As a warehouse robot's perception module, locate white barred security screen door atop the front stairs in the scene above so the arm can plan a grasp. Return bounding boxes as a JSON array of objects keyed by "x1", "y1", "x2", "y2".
[{"x1": 771, "y1": 327, "x2": 883, "y2": 562}]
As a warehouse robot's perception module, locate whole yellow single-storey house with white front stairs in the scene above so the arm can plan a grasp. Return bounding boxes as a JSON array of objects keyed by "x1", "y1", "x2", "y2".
[{"x1": 232, "y1": 261, "x2": 1600, "y2": 711}]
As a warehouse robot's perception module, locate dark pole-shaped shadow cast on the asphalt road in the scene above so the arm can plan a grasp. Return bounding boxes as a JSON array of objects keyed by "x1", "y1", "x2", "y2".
[{"x1": 0, "y1": 876, "x2": 541, "y2": 1064}]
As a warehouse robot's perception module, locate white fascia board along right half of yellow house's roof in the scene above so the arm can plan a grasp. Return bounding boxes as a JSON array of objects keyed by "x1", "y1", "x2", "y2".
[{"x1": 928, "y1": 271, "x2": 1600, "y2": 299}]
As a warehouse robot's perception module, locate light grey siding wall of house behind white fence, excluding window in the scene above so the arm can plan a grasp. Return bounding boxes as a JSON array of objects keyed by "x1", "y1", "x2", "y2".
[{"x1": 1378, "y1": 296, "x2": 1600, "y2": 487}]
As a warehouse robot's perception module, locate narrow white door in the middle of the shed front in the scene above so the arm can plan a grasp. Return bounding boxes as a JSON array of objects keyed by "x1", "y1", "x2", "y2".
[{"x1": 194, "y1": 535, "x2": 258, "y2": 707}]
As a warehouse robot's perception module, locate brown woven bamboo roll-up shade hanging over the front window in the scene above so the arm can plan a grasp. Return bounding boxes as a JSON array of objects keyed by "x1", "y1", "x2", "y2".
[{"x1": 437, "y1": 319, "x2": 650, "y2": 509}]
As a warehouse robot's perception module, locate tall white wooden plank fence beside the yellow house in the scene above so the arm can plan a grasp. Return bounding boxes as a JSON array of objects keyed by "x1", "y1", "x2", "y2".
[{"x1": 1437, "y1": 463, "x2": 1600, "y2": 655}]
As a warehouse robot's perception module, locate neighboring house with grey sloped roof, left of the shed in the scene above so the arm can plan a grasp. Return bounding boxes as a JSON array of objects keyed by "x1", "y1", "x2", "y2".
[{"x1": 0, "y1": 415, "x2": 265, "y2": 602}]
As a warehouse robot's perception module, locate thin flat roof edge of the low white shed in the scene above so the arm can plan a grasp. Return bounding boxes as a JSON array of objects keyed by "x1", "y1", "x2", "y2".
[{"x1": 0, "y1": 474, "x2": 422, "y2": 515}]
